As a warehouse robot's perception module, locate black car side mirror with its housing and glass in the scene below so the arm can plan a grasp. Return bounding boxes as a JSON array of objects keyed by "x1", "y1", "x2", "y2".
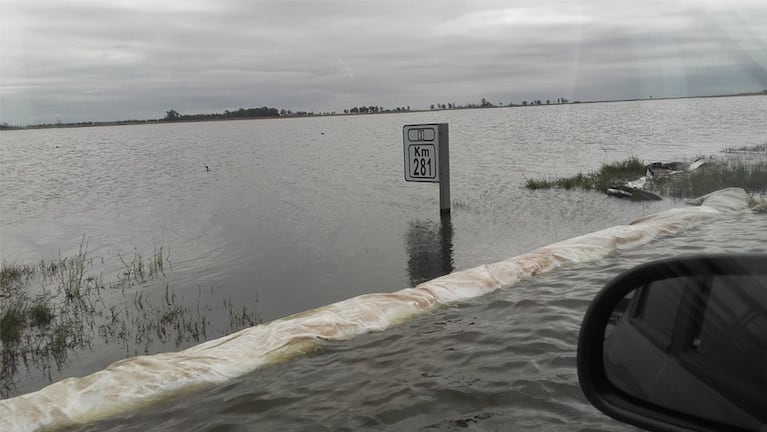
[{"x1": 578, "y1": 254, "x2": 767, "y2": 431}]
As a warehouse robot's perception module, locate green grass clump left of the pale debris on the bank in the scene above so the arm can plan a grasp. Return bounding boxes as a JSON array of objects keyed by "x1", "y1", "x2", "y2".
[{"x1": 525, "y1": 157, "x2": 645, "y2": 192}]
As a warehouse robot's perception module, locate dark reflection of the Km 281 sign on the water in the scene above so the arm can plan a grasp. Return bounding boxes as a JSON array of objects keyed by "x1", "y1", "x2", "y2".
[{"x1": 407, "y1": 217, "x2": 453, "y2": 286}]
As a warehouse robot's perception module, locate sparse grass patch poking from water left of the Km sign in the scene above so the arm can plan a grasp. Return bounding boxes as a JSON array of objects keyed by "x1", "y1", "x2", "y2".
[{"x1": 0, "y1": 241, "x2": 261, "y2": 397}]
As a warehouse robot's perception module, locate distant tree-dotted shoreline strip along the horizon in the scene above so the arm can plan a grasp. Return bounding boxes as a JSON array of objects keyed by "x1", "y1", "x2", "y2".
[{"x1": 0, "y1": 90, "x2": 767, "y2": 131}]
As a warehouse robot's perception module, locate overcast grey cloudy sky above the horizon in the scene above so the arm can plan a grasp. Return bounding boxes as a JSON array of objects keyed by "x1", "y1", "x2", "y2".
[{"x1": 0, "y1": 0, "x2": 767, "y2": 125}]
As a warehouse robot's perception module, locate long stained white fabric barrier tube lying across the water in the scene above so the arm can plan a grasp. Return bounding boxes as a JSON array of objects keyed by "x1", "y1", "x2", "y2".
[{"x1": 0, "y1": 188, "x2": 749, "y2": 432}]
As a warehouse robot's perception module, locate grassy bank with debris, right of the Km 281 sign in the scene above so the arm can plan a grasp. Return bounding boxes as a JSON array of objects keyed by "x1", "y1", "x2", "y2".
[{"x1": 525, "y1": 143, "x2": 767, "y2": 198}]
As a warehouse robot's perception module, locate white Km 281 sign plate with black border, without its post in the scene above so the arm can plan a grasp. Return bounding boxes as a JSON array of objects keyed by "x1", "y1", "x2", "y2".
[{"x1": 402, "y1": 124, "x2": 439, "y2": 183}]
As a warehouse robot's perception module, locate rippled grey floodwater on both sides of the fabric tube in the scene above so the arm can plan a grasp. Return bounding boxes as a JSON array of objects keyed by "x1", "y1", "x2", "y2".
[{"x1": 0, "y1": 97, "x2": 767, "y2": 431}]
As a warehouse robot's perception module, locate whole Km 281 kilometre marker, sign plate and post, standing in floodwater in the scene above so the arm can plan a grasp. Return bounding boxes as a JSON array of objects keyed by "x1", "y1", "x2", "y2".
[{"x1": 402, "y1": 123, "x2": 450, "y2": 218}]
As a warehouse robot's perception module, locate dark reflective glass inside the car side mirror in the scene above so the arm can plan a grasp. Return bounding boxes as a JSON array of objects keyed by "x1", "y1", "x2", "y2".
[{"x1": 604, "y1": 274, "x2": 767, "y2": 429}]
